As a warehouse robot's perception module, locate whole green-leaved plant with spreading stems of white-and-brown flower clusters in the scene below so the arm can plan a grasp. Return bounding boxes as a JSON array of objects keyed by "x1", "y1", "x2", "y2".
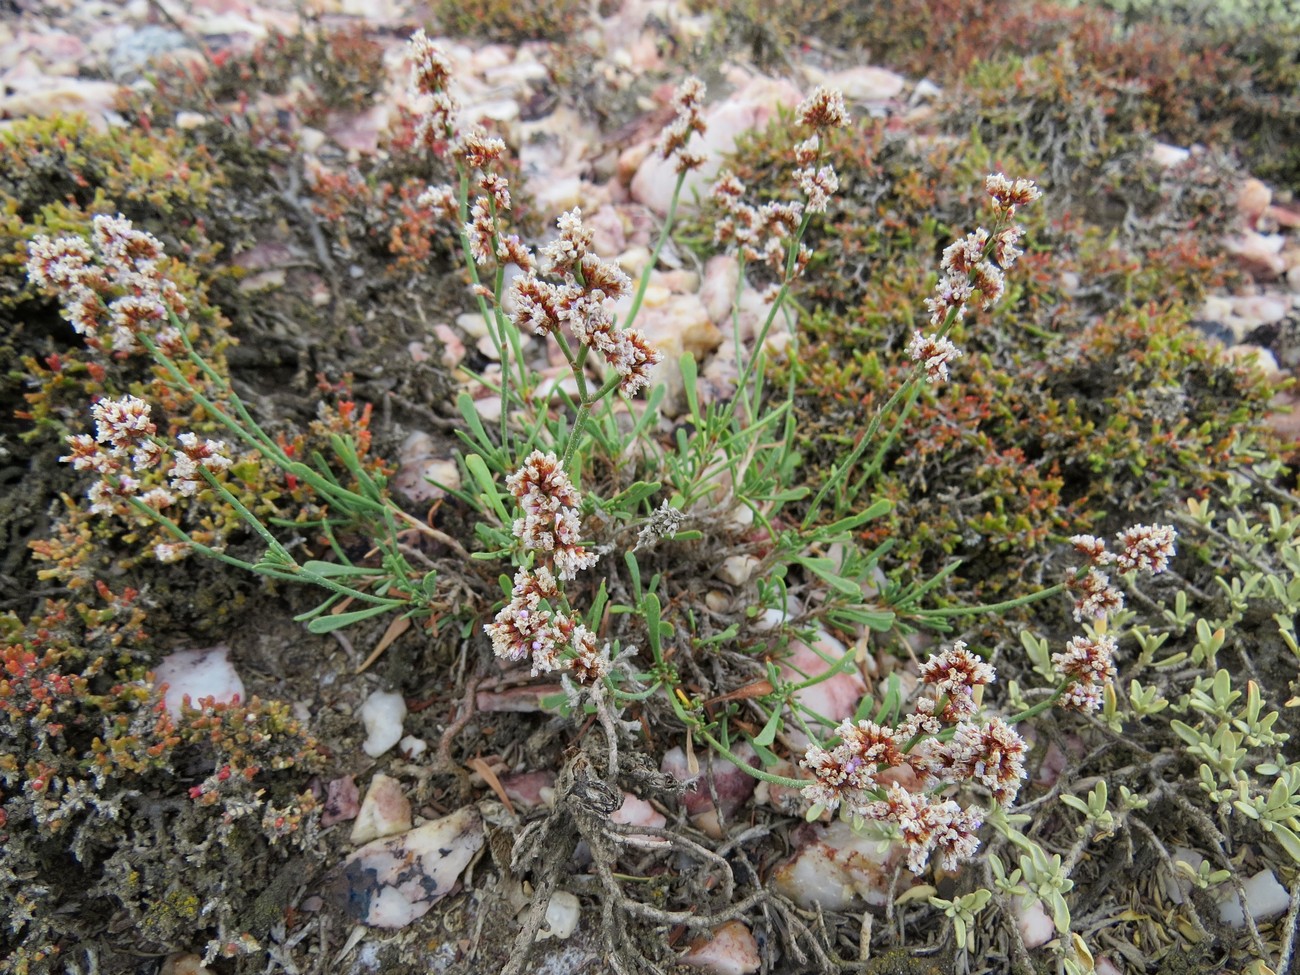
[{"x1": 29, "y1": 26, "x2": 1196, "y2": 972}]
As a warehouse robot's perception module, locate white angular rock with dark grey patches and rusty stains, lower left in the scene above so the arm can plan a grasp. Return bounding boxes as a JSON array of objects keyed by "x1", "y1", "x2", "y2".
[{"x1": 322, "y1": 806, "x2": 484, "y2": 928}]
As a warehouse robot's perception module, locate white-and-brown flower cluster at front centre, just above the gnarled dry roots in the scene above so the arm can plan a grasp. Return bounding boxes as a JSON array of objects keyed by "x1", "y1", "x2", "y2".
[{"x1": 485, "y1": 450, "x2": 610, "y2": 685}]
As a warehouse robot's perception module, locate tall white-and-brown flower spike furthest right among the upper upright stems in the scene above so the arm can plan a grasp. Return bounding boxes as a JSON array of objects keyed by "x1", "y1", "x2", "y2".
[{"x1": 907, "y1": 173, "x2": 1043, "y2": 382}]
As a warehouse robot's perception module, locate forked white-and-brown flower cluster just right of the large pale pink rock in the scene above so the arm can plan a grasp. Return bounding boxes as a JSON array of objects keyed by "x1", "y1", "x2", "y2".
[{"x1": 710, "y1": 87, "x2": 849, "y2": 276}]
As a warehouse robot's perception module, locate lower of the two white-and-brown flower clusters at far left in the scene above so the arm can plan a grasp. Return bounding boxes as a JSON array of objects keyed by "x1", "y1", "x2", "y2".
[{"x1": 59, "y1": 397, "x2": 230, "y2": 551}]
